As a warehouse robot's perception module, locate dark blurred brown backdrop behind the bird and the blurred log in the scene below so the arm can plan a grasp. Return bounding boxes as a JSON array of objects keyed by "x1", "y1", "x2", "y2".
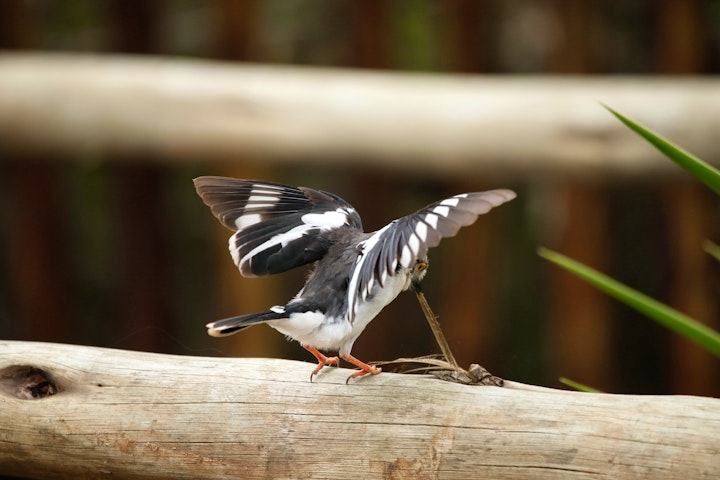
[{"x1": 0, "y1": 0, "x2": 720, "y2": 396}]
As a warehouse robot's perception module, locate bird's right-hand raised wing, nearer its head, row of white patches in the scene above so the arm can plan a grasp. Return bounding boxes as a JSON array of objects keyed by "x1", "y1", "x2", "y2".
[{"x1": 348, "y1": 189, "x2": 515, "y2": 321}]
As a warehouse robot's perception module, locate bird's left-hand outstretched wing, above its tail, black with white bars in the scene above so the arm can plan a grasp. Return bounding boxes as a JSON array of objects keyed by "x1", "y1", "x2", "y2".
[{"x1": 194, "y1": 177, "x2": 362, "y2": 277}]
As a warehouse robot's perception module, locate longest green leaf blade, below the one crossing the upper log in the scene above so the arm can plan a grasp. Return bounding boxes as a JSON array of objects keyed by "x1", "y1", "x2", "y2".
[{"x1": 538, "y1": 248, "x2": 720, "y2": 357}]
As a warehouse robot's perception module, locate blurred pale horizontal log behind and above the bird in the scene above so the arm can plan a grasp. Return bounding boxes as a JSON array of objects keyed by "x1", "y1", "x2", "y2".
[{"x1": 0, "y1": 53, "x2": 720, "y2": 176}]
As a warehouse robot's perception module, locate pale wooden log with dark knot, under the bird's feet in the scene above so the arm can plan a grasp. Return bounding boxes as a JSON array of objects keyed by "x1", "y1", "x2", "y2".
[{"x1": 0, "y1": 341, "x2": 720, "y2": 480}]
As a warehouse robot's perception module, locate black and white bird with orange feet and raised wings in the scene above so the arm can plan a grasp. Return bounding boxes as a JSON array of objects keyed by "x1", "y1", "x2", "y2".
[{"x1": 194, "y1": 177, "x2": 515, "y2": 380}]
